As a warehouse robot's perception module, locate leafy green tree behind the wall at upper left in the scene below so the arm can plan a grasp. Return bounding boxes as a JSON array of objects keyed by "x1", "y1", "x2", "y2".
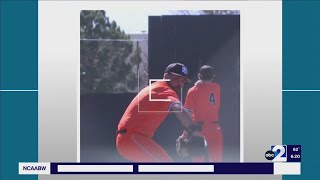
[{"x1": 80, "y1": 10, "x2": 139, "y2": 94}]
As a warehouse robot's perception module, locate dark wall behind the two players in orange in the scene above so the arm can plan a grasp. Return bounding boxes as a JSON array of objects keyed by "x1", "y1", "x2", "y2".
[{"x1": 80, "y1": 15, "x2": 240, "y2": 162}]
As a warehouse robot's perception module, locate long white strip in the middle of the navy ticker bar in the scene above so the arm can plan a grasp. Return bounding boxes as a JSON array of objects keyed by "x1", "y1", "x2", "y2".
[{"x1": 138, "y1": 165, "x2": 214, "y2": 172}]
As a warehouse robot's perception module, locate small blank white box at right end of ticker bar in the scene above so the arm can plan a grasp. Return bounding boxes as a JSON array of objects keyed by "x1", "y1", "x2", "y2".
[{"x1": 273, "y1": 162, "x2": 301, "y2": 175}]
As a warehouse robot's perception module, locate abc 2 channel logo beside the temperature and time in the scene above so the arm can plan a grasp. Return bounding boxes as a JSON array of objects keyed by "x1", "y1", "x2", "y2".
[{"x1": 264, "y1": 145, "x2": 287, "y2": 162}]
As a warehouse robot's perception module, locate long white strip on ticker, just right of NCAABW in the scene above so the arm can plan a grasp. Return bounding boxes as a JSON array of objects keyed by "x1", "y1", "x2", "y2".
[{"x1": 58, "y1": 165, "x2": 133, "y2": 172}]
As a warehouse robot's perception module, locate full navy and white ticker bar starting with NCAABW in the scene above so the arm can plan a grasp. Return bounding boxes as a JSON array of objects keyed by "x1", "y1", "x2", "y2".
[{"x1": 19, "y1": 162, "x2": 301, "y2": 175}]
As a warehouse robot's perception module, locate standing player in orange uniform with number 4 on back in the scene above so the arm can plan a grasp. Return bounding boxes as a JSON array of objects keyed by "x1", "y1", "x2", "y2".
[{"x1": 185, "y1": 65, "x2": 223, "y2": 162}]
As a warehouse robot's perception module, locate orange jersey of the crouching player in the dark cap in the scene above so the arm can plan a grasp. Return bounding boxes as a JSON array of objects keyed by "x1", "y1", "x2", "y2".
[{"x1": 118, "y1": 81, "x2": 180, "y2": 137}]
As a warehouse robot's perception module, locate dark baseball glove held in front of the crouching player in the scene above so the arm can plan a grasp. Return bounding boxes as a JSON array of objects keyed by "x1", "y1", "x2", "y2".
[{"x1": 176, "y1": 135, "x2": 207, "y2": 158}]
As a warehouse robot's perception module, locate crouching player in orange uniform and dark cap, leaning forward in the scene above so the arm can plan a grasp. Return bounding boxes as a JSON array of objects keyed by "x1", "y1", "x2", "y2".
[{"x1": 116, "y1": 63, "x2": 199, "y2": 162}]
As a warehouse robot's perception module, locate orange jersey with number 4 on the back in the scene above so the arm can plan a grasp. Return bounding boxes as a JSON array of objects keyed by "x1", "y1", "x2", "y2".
[{"x1": 184, "y1": 82, "x2": 220, "y2": 122}]
